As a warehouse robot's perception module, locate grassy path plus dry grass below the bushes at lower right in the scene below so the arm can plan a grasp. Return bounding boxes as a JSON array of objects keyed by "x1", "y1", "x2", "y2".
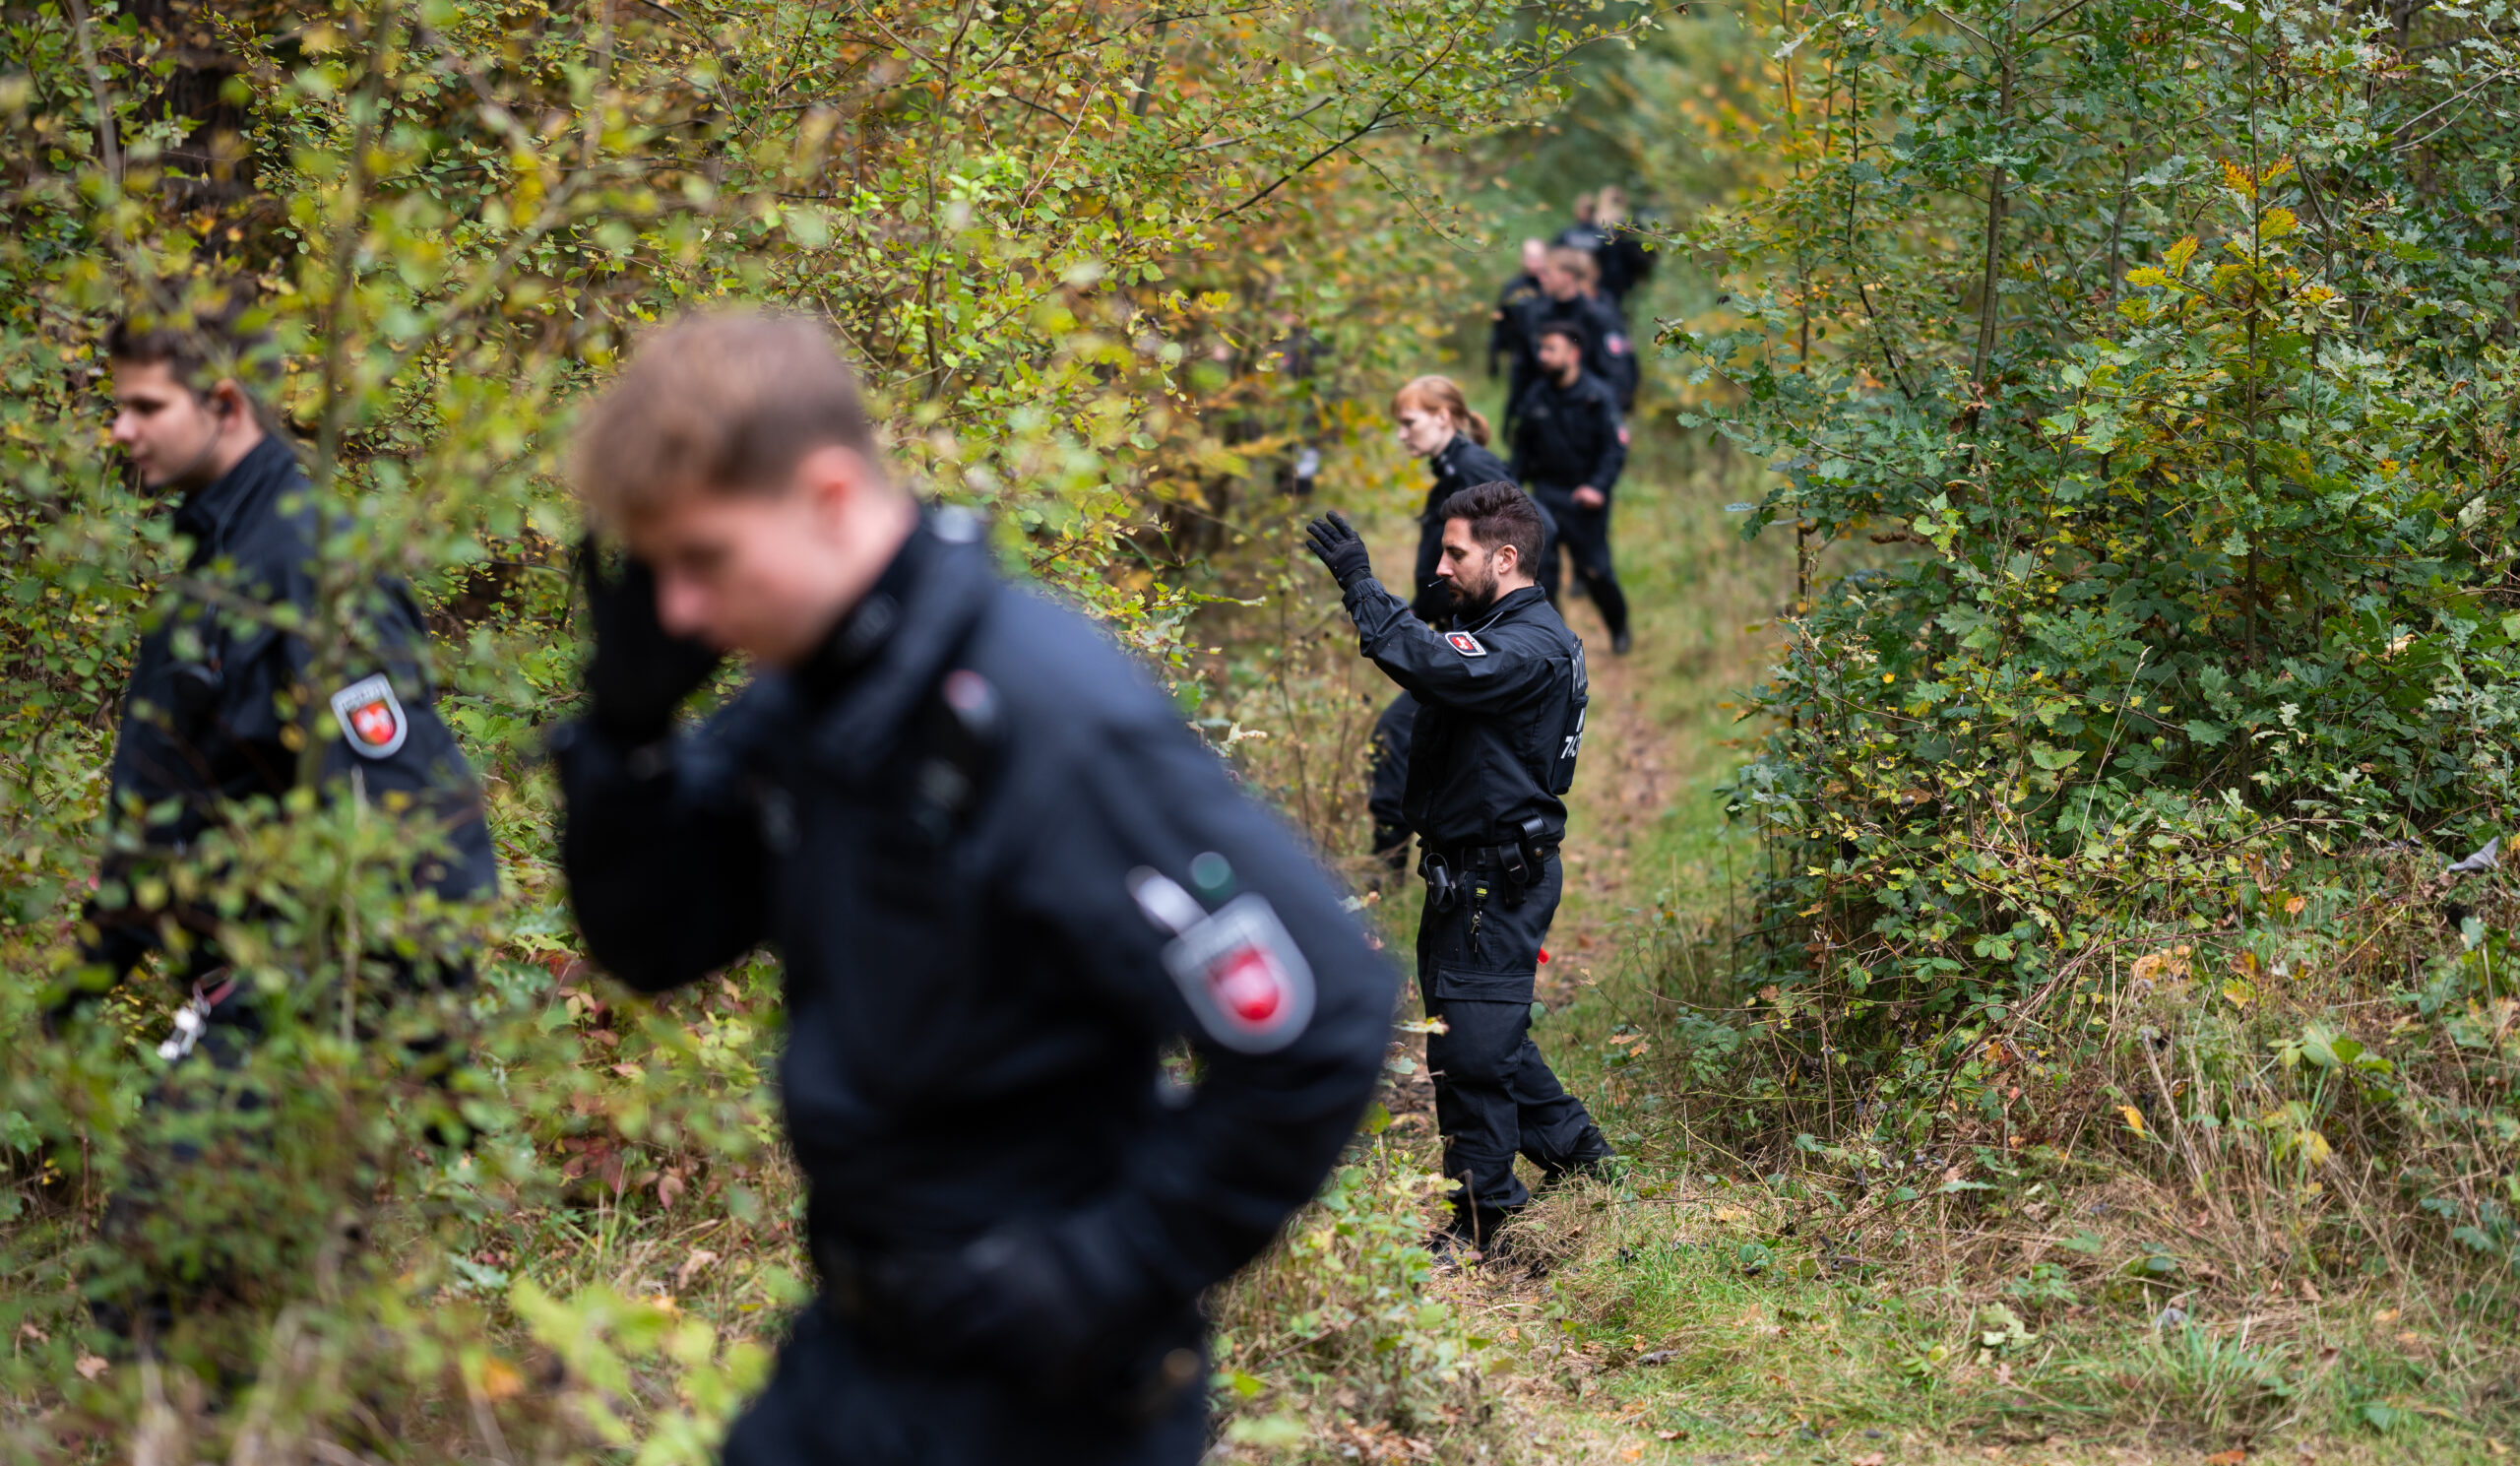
[{"x1": 1420, "y1": 435, "x2": 2520, "y2": 1461}]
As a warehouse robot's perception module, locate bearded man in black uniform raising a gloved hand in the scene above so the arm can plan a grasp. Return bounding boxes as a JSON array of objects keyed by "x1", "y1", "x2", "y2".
[{"x1": 1308, "y1": 483, "x2": 1610, "y2": 1249}]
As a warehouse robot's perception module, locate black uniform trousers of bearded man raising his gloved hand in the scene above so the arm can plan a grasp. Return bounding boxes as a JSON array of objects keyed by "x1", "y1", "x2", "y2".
[{"x1": 1418, "y1": 852, "x2": 1610, "y2": 1244}]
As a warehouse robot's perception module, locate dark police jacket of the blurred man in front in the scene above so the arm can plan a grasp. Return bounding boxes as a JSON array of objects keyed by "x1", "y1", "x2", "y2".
[{"x1": 557, "y1": 516, "x2": 1396, "y2": 1390}]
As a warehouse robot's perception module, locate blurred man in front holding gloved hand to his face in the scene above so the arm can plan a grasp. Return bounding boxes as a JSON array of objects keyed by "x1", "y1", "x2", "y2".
[{"x1": 557, "y1": 315, "x2": 1394, "y2": 1466}]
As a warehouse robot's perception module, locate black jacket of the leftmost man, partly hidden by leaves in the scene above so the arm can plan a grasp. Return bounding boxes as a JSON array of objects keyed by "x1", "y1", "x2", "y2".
[{"x1": 86, "y1": 436, "x2": 499, "y2": 978}]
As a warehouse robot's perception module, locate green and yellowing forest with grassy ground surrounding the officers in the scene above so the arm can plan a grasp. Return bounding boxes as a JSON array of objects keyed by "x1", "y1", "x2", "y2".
[{"x1": 0, "y1": 0, "x2": 2520, "y2": 1463}]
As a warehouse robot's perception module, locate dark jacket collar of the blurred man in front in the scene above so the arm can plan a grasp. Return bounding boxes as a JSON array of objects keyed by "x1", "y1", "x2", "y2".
[{"x1": 806, "y1": 514, "x2": 998, "y2": 779}]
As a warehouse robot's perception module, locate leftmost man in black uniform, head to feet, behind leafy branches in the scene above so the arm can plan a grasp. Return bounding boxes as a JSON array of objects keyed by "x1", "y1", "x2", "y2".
[{"x1": 45, "y1": 302, "x2": 499, "y2": 1345}]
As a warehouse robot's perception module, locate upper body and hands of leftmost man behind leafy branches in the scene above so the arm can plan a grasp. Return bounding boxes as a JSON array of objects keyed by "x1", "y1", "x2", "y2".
[{"x1": 53, "y1": 297, "x2": 499, "y2": 1063}]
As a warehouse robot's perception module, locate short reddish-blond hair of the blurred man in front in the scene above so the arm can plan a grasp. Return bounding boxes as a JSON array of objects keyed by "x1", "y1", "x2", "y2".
[{"x1": 570, "y1": 310, "x2": 882, "y2": 527}]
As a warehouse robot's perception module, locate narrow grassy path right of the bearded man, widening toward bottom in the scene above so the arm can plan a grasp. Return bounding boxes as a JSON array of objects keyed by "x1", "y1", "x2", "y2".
[{"x1": 1399, "y1": 443, "x2": 2507, "y2": 1466}]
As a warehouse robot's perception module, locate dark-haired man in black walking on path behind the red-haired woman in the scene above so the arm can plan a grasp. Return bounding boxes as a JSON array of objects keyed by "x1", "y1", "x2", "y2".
[{"x1": 1515, "y1": 322, "x2": 1630, "y2": 655}]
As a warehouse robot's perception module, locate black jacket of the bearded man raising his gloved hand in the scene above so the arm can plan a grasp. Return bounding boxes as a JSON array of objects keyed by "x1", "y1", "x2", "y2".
[{"x1": 1346, "y1": 577, "x2": 1588, "y2": 852}]
